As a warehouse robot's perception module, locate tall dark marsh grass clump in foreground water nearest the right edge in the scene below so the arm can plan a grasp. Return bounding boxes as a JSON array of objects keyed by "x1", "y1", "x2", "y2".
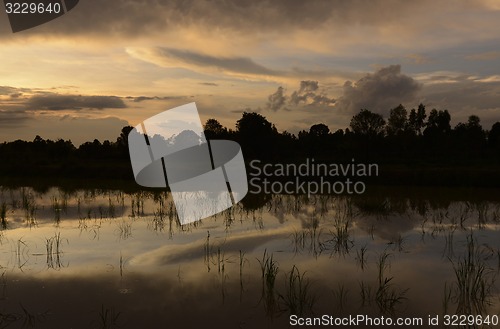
[{"x1": 450, "y1": 234, "x2": 495, "y2": 314}]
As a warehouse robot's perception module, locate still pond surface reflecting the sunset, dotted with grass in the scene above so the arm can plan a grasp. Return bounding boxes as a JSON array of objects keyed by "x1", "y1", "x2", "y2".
[{"x1": 0, "y1": 187, "x2": 500, "y2": 328}]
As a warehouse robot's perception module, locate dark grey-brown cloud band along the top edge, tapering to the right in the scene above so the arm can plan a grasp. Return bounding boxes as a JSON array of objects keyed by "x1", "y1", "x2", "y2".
[{"x1": 0, "y1": 0, "x2": 454, "y2": 38}]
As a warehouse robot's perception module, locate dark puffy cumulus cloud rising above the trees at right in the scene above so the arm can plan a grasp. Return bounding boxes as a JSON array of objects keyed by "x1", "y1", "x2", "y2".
[{"x1": 337, "y1": 65, "x2": 422, "y2": 115}]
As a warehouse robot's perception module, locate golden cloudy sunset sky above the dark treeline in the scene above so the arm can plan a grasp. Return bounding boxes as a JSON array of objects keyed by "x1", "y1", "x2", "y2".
[{"x1": 0, "y1": 0, "x2": 500, "y2": 145}]
